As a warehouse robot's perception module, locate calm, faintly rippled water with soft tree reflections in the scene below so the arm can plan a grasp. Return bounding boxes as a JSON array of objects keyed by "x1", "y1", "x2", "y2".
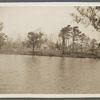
[{"x1": 0, "y1": 55, "x2": 100, "y2": 94}]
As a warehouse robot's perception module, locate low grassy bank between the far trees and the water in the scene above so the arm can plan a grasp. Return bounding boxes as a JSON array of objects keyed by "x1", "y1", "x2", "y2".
[{"x1": 0, "y1": 50, "x2": 100, "y2": 58}]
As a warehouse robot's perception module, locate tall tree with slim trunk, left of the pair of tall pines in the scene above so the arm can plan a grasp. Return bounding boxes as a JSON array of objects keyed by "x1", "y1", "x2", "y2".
[{"x1": 59, "y1": 25, "x2": 72, "y2": 54}]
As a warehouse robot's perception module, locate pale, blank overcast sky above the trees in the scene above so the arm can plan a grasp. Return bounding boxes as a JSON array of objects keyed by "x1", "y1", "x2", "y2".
[{"x1": 0, "y1": 7, "x2": 100, "y2": 39}]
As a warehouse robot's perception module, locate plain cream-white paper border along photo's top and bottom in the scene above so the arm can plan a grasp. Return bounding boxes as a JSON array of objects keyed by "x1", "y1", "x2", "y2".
[{"x1": 0, "y1": 0, "x2": 100, "y2": 98}]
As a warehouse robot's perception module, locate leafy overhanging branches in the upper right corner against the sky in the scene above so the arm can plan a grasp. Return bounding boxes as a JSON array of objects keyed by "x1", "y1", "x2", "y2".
[{"x1": 71, "y1": 6, "x2": 100, "y2": 31}]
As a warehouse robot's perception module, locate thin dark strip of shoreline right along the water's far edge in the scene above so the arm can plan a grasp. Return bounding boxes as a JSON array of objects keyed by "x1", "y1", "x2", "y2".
[{"x1": 0, "y1": 52, "x2": 100, "y2": 59}]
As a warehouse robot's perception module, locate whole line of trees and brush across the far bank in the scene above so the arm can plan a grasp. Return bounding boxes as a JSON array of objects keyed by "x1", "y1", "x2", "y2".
[{"x1": 0, "y1": 25, "x2": 99, "y2": 55}]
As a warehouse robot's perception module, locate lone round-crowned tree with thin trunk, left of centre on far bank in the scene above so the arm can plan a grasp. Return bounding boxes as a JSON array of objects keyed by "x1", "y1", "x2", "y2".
[{"x1": 27, "y1": 32, "x2": 43, "y2": 53}]
